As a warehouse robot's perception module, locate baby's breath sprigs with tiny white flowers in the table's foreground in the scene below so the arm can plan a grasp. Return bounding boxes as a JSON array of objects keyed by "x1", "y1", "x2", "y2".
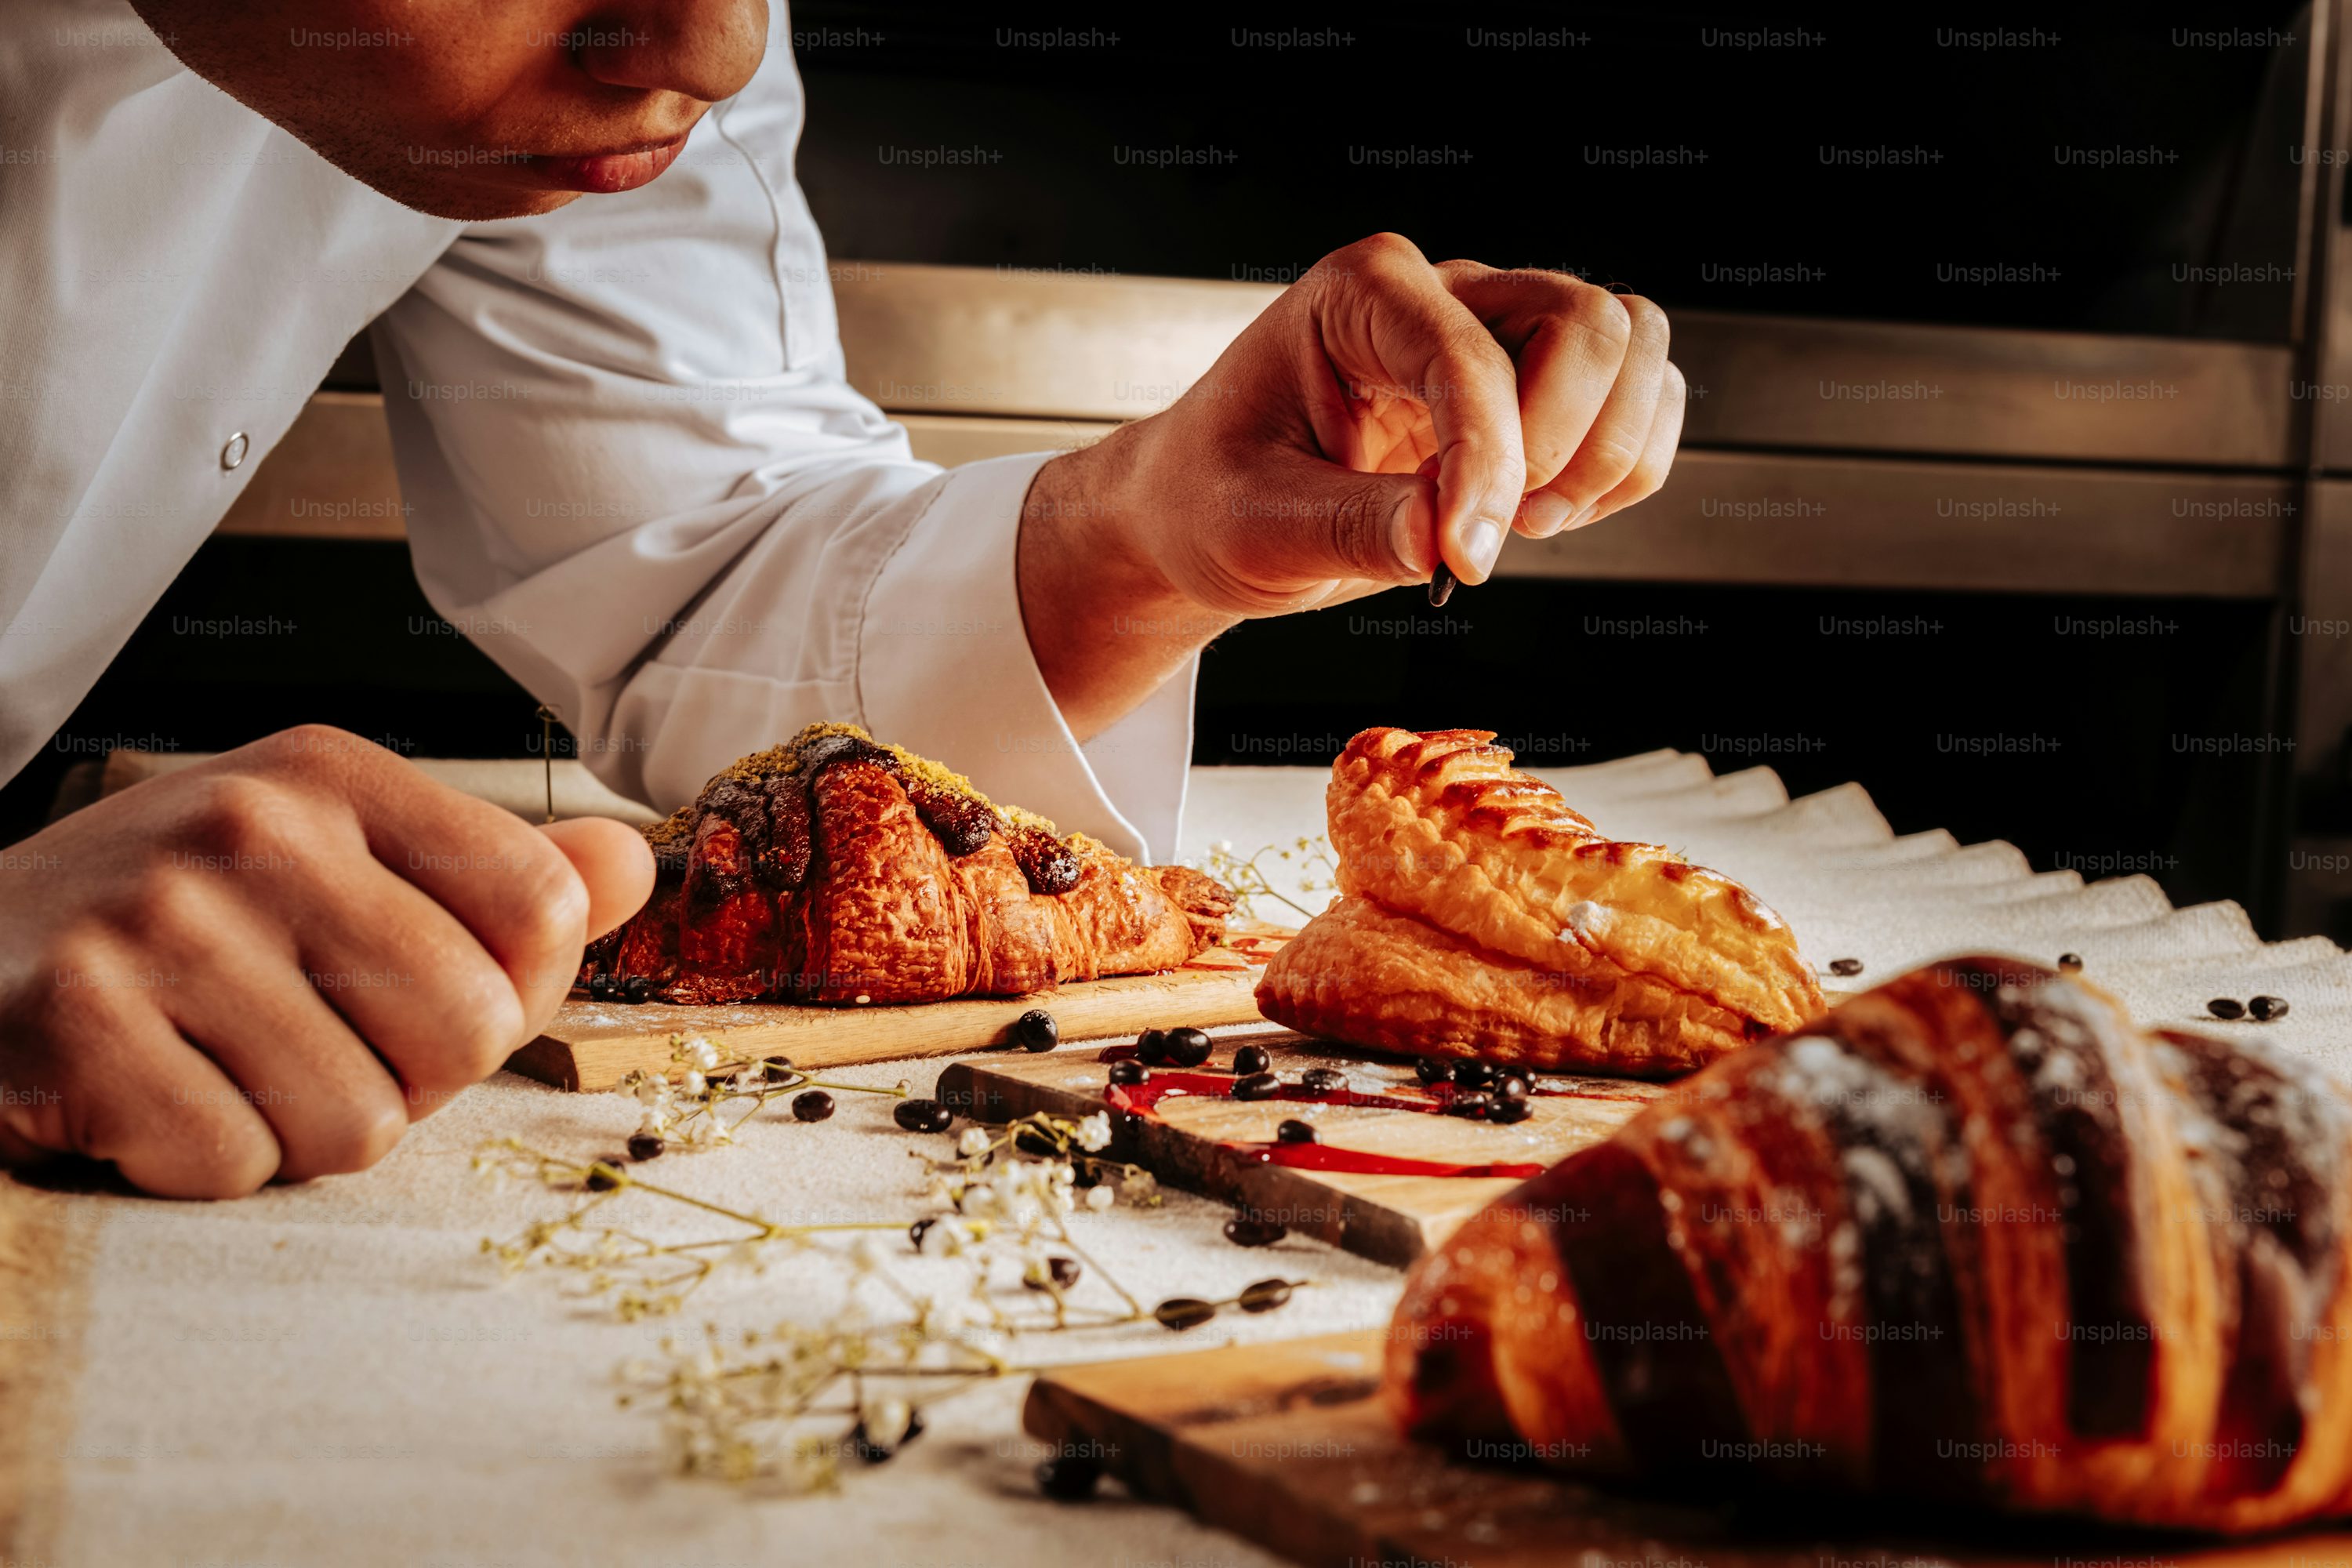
[{"x1": 475, "y1": 1105, "x2": 1308, "y2": 1490}]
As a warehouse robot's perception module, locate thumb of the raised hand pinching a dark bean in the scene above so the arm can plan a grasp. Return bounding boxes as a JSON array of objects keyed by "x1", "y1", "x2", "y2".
[{"x1": 1249, "y1": 452, "x2": 1437, "y2": 594}]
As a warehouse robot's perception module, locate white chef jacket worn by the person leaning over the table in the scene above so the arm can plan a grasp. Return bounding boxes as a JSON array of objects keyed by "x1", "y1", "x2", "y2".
[{"x1": 0, "y1": 0, "x2": 1197, "y2": 855}]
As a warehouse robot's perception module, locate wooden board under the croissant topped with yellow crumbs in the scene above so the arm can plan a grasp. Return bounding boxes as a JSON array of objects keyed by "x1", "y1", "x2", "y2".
[{"x1": 506, "y1": 945, "x2": 1289, "y2": 1093}]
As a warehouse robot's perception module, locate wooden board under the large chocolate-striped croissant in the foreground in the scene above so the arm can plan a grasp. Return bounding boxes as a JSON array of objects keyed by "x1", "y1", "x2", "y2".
[{"x1": 1023, "y1": 1328, "x2": 2352, "y2": 1568}]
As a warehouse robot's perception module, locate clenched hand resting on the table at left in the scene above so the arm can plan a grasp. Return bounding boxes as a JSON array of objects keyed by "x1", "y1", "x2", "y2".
[{"x1": 0, "y1": 724, "x2": 654, "y2": 1196}]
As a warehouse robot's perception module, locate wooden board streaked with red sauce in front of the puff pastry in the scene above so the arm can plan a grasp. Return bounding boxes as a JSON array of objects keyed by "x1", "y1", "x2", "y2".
[{"x1": 938, "y1": 1032, "x2": 1665, "y2": 1267}]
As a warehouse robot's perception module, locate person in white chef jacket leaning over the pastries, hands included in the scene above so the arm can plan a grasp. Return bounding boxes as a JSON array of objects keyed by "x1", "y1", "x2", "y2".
[{"x1": 0, "y1": 0, "x2": 1684, "y2": 1196}]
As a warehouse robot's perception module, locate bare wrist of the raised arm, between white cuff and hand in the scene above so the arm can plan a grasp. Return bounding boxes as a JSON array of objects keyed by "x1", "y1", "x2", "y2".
[{"x1": 1018, "y1": 423, "x2": 1240, "y2": 741}]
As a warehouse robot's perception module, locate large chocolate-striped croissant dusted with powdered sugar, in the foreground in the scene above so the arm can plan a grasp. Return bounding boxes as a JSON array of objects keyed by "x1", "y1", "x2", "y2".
[{"x1": 1388, "y1": 959, "x2": 2352, "y2": 1533}]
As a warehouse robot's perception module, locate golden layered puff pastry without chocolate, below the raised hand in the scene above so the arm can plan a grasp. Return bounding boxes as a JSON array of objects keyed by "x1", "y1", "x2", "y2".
[{"x1": 1258, "y1": 729, "x2": 1823, "y2": 1076}]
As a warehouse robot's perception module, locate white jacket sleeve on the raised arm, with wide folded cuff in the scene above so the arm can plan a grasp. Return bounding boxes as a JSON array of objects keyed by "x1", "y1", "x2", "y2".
[{"x1": 374, "y1": 5, "x2": 1197, "y2": 855}]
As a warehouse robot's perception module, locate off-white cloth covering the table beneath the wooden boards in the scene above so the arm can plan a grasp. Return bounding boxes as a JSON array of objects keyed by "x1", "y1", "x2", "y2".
[{"x1": 0, "y1": 753, "x2": 2352, "y2": 1568}]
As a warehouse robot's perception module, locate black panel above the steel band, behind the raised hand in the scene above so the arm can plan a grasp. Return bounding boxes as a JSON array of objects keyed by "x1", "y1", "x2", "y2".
[{"x1": 793, "y1": 2, "x2": 2305, "y2": 339}]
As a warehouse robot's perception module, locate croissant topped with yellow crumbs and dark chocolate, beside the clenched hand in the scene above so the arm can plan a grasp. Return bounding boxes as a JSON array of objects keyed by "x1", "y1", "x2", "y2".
[{"x1": 581, "y1": 724, "x2": 1232, "y2": 1001}]
